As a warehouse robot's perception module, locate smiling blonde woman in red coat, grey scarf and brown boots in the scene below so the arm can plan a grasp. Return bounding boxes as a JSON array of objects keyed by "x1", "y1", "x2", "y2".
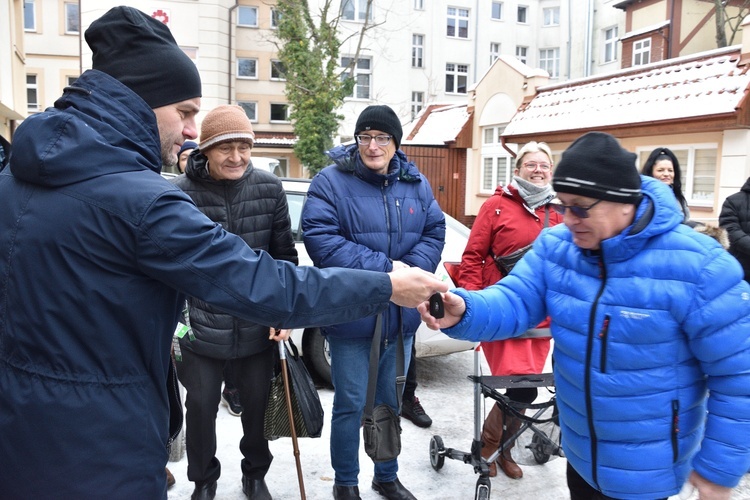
[{"x1": 459, "y1": 141, "x2": 562, "y2": 479}]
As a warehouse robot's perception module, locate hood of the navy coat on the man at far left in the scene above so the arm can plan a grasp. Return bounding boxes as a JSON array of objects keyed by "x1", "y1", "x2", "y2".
[{"x1": 10, "y1": 70, "x2": 161, "y2": 187}]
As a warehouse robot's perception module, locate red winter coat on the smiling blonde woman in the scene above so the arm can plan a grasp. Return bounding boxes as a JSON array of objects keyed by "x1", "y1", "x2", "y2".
[{"x1": 459, "y1": 186, "x2": 563, "y2": 376}]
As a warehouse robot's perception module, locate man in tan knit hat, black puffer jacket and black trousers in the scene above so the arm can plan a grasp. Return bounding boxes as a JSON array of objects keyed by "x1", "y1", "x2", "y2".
[{"x1": 174, "y1": 105, "x2": 297, "y2": 500}]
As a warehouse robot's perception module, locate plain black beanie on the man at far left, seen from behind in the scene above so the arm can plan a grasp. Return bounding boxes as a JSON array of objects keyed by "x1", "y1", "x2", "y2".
[{"x1": 85, "y1": 6, "x2": 201, "y2": 109}]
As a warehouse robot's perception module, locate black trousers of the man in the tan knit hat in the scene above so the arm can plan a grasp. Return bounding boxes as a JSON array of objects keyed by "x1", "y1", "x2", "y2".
[{"x1": 177, "y1": 348, "x2": 274, "y2": 483}]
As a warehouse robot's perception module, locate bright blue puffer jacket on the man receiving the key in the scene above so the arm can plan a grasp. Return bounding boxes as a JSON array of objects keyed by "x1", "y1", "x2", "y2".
[{"x1": 444, "y1": 177, "x2": 750, "y2": 499}]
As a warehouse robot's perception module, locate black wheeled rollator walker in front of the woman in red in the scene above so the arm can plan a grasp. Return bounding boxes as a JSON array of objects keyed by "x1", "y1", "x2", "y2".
[{"x1": 430, "y1": 263, "x2": 564, "y2": 500}]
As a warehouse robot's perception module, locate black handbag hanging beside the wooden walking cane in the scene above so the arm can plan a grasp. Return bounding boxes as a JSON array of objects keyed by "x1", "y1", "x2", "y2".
[{"x1": 263, "y1": 339, "x2": 323, "y2": 441}]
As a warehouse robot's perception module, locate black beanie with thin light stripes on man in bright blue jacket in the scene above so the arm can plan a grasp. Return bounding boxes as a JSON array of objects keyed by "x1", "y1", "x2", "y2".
[{"x1": 552, "y1": 132, "x2": 641, "y2": 204}]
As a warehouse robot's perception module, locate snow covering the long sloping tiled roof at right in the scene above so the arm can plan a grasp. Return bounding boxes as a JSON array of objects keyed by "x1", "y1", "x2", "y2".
[{"x1": 503, "y1": 47, "x2": 750, "y2": 136}]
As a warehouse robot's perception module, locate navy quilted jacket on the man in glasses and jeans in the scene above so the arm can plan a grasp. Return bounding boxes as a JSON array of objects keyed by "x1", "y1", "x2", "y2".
[{"x1": 302, "y1": 145, "x2": 445, "y2": 339}]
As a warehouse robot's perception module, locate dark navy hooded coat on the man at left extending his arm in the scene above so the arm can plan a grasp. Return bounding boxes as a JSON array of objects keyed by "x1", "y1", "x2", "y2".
[{"x1": 0, "y1": 71, "x2": 392, "y2": 500}]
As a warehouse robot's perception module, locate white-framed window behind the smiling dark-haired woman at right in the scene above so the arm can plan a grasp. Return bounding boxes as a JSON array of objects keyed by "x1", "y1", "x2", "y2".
[{"x1": 636, "y1": 142, "x2": 719, "y2": 208}]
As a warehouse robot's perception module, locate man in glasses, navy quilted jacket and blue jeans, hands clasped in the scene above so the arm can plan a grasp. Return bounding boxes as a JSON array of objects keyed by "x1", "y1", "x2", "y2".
[{"x1": 302, "y1": 105, "x2": 445, "y2": 500}]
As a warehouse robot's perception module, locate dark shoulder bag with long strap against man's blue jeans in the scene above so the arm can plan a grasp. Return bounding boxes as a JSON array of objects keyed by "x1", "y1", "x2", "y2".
[{"x1": 362, "y1": 314, "x2": 406, "y2": 462}]
